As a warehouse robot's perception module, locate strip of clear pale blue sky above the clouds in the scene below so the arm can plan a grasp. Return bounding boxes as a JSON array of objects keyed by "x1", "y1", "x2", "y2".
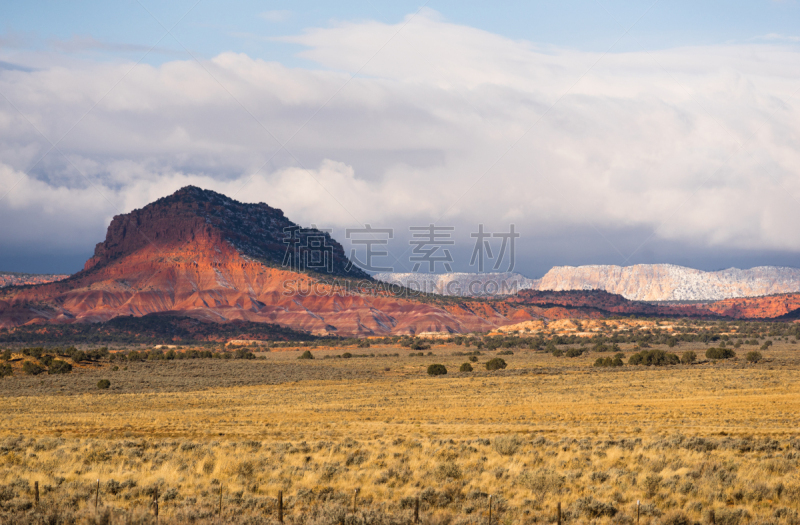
[{"x1": 6, "y1": 0, "x2": 800, "y2": 65}]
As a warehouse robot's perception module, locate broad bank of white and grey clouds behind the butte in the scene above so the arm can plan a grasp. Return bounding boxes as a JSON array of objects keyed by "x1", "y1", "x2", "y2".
[{"x1": 0, "y1": 11, "x2": 800, "y2": 270}]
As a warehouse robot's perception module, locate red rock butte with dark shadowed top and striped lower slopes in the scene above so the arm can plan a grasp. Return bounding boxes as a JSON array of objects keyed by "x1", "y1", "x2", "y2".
[{"x1": 0, "y1": 186, "x2": 511, "y2": 335}]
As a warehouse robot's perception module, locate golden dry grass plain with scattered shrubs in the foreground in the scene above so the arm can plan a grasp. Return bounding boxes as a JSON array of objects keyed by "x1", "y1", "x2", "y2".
[{"x1": 0, "y1": 341, "x2": 800, "y2": 525}]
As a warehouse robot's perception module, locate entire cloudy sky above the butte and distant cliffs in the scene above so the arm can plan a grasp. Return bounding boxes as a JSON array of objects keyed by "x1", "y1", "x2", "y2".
[{"x1": 0, "y1": 0, "x2": 800, "y2": 277}]
